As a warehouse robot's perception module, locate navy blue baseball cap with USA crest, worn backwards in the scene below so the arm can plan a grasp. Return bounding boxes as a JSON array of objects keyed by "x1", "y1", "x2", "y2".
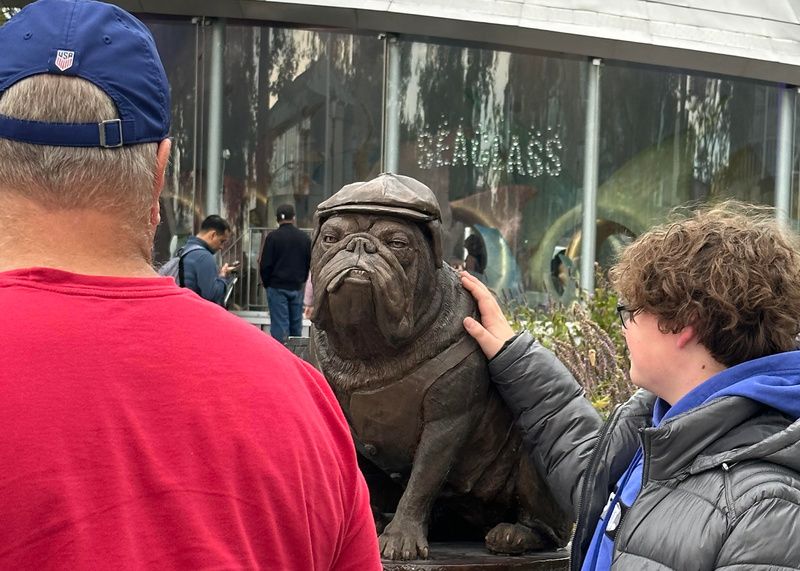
[{"x1": 0, "y1": 0, "x2": 170, "y2": 148}]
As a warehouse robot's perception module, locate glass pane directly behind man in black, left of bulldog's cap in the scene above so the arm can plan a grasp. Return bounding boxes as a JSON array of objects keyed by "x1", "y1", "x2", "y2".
[{"x1": 217, "y1": 25, "x2": 383, "y2": 307}]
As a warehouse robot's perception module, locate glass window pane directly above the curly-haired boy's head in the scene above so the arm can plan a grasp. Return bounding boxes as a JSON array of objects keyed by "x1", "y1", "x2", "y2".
[{"x1": 597, "y1": 64, "x2": 778, "y2": 266}]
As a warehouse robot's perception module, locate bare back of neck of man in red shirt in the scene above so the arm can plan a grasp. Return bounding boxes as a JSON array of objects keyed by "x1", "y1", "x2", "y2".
[{"x1": 0, "y1": 197, "x2": 155, "y2": 277}]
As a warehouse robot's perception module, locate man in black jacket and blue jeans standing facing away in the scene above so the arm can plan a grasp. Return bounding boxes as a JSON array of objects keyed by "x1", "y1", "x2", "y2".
[{"x1": 260, "y1": 204, "x2": 311, "y2": 343}]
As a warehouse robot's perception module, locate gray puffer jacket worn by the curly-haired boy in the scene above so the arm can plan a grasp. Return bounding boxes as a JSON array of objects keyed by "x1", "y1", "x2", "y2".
[{"x1": 489, "y1": 333, "x2": 800, "y2": 571}]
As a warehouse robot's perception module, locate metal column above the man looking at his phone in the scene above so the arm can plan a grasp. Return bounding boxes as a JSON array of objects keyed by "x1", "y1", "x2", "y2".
[{"x1": 203, "y1": 19, "x2": 225, "y2": 216}]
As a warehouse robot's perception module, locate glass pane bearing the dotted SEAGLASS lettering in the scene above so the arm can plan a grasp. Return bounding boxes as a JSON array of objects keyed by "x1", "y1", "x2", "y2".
[{"x1": 398, "y1": 41, "x2": 585, "y2": 297}]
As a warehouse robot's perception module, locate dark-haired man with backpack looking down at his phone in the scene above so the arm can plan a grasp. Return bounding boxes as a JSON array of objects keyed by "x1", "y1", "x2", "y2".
[{"x1": 182, "y1": 214, "x2": 235, "y2": 305}]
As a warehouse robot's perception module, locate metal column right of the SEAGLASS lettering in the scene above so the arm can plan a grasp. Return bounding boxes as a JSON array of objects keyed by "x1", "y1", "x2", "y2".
[{"x1": 580, "y1": 58, "x2": 602, "y2": 295}]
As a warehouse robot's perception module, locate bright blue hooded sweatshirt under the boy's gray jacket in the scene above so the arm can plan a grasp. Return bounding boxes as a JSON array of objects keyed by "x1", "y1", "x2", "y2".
[{"x1": 581, "y1": 351, "x2": 800, "y2": 571}]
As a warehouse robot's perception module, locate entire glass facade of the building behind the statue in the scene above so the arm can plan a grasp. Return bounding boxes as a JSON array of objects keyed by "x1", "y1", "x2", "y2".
[{"x1": 3, "y1": 10, "x2": 800, "y2": 307}]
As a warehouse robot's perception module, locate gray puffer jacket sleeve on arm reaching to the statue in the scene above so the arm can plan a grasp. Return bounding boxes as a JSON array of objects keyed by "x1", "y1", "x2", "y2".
[{"x1": 489, "y1": 332, "x2": 602, "y2": 514}]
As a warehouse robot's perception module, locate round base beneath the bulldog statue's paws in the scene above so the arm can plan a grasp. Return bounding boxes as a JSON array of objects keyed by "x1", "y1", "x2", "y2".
[{"x1": 381, "y1": 542, "x2": 569, "y2": 571}]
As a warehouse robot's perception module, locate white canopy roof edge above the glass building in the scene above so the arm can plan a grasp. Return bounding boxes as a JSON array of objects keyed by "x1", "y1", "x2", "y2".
[{"x1": 20, "y1": 0, "x2": 800, "y2": 85}]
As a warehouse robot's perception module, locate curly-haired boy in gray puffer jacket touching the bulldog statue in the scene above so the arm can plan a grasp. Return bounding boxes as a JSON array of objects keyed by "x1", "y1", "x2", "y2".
[{"x1": 462, "y1": 202, "x2": 800, "y2": 571}]
